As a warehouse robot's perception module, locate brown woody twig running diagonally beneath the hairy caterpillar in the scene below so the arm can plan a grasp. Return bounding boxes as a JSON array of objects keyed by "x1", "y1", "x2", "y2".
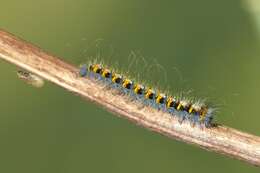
[{"x1": 0, "y1": 31, "x2": 260, "y2": 166}]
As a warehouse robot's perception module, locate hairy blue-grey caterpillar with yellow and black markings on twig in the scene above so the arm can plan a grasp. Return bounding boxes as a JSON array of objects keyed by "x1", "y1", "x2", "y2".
[{"x1": 79, "y1": 63, "x2": 214, "y2": 128}]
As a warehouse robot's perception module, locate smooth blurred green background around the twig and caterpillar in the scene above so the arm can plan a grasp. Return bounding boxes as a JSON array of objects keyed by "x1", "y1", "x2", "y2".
[{"x1": 0, "y1": 0, "x2": 260, "y2": 173}]
